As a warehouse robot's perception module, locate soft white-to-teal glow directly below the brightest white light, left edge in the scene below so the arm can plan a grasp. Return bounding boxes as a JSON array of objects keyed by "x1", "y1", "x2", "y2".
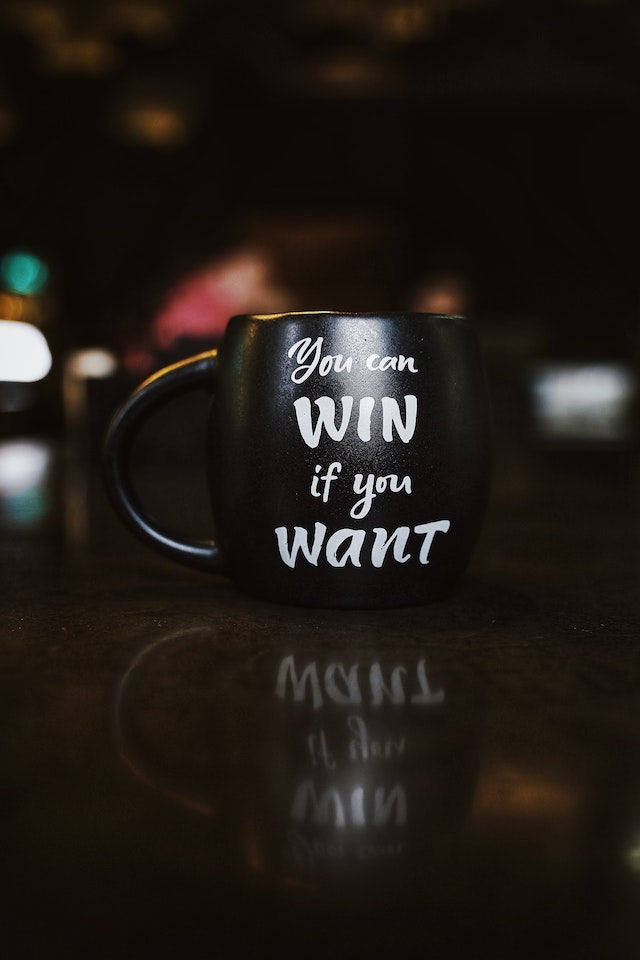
[{"x1": 0, "y1": 440, "x2": 52, "y2": 528}]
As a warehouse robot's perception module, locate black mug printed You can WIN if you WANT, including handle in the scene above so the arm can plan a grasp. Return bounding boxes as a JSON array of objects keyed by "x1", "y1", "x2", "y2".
[{"x1": 104, "y1": 312, "x2": 491, "y2": 608}]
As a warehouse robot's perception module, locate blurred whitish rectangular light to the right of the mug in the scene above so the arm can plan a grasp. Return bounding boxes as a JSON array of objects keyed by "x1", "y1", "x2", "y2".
[{"x1": 530, "y1": 363, "x2": 637, "y2": 443}]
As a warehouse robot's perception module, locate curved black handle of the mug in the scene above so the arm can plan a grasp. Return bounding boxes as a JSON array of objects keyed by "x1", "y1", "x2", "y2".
[{"x1": 103, "y1": 350, "x2": 225, "y2": 573}]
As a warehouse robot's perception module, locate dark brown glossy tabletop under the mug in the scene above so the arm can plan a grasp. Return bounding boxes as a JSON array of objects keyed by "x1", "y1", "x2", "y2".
[{"x1": 0, "y1": 440, "x2": 640, "y2": 960}]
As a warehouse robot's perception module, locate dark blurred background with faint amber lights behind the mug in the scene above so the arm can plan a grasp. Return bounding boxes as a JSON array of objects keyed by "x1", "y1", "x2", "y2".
[{"x1": 0, "y1": 0, "x2": 640, "y2": 446}]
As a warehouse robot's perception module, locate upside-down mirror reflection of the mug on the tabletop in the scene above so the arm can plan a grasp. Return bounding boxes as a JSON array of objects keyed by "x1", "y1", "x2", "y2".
[{"x1": 113, "y1": 621, "x2": 480, "y2": 903}]
